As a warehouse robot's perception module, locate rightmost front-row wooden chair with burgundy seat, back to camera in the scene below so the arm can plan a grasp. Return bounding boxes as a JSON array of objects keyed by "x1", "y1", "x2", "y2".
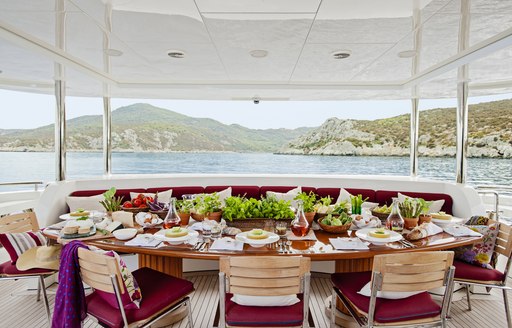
[{"x1": 331, "y1": 252, "x2": 455, "y2": 327}]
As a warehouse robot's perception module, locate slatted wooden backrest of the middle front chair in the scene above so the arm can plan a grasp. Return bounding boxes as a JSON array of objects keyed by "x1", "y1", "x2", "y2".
[{"x1": 220, "y1": 256, "x2": 311, "y2": 296}]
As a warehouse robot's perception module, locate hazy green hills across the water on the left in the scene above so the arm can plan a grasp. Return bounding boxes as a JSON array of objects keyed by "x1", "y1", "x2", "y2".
[{"x1": 0, "y1": 104, "x2": 309, "y2": 152}]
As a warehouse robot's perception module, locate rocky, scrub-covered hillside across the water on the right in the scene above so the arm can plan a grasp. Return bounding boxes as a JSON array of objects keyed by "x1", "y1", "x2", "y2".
[{"x1": 280, "y1": 100, "x2": 512, "y2": 158}]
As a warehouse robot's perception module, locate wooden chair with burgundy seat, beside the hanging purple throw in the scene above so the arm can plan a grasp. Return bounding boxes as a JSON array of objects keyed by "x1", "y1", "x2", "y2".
[{"x1": 78, "y1": 248, "x2": 194, "y2": 328}]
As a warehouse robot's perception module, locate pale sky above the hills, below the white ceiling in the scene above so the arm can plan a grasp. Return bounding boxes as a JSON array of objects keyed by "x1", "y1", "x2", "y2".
[{"x1": 0, "y1": 90, "x2": 512, "y2": 129}]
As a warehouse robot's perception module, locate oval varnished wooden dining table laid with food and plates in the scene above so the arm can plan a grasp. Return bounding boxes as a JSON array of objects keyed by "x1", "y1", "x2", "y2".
[{"x1": 49, "y1": 229, "x2": 481, "y2": 327}]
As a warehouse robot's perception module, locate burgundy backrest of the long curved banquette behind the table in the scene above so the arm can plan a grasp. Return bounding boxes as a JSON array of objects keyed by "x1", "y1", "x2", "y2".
[{"x1": 70, "y1": 185, "x2": 453, "y2": 214}]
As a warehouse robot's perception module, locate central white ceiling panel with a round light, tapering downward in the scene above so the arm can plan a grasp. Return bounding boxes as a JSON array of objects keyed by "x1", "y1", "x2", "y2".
[{"x1": 204, "y1": 14, "x2": 313, "y2": 81}]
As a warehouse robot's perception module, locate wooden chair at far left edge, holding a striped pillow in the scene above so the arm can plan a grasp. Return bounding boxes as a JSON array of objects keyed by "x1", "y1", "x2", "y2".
[{"x1": 0, "y1": 212, "x2": 52, "y2": 323}]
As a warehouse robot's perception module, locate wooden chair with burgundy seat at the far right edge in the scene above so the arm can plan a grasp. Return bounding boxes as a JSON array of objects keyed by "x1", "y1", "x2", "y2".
[{"x1": 453, "y1": 220, "x2": 512, "y2": 328}]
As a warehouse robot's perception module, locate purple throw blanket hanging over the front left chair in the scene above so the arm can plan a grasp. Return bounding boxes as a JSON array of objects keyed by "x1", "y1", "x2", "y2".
[{"x1": 52, "y1": 240, "x2": 88, "y2": 328}]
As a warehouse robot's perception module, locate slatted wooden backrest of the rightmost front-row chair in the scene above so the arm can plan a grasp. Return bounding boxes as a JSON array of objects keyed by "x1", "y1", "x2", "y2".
[{"x1": 373, "y1": 252, "x2": 453, "y2": 292}]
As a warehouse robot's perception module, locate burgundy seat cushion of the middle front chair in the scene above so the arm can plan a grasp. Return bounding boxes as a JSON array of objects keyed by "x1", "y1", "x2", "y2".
[{"x1": 226, "y1": 294, "x2": 304, "y2": 327}]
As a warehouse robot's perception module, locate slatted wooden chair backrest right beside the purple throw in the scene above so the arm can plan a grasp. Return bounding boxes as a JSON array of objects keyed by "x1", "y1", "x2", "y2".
[{"x1": 78, "y1": 248, "x2": 124, "y2": 294}]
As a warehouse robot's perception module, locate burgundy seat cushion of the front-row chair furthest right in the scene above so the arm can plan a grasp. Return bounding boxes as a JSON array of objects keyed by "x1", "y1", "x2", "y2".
[{"x1": 331, "y1": 272, "x2": 441, "y2": 323}]
